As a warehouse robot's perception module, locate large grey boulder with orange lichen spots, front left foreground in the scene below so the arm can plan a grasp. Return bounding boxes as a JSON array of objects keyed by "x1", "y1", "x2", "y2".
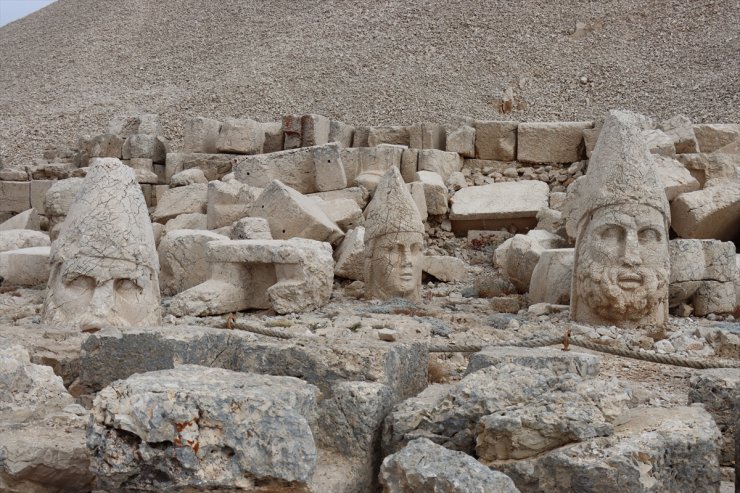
[{"x1": 87, "y1": 365, "x2": 319, "y2": 491}]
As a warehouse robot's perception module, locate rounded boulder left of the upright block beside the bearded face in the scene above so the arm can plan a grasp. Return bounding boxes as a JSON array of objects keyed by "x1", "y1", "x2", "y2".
[{"x1": 494, "y1": 229, "x2": 563, "y2": 293}]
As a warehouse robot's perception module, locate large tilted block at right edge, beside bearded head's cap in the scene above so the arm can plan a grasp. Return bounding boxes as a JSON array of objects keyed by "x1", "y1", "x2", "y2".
[{"x1": 671, "y1": 179, "x2": 740, "y2": 241}]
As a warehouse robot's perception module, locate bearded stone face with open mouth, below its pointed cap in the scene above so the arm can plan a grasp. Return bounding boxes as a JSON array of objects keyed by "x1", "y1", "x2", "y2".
[{"x1": 573, "y1": 205, "x2": 670, "y2": 326}]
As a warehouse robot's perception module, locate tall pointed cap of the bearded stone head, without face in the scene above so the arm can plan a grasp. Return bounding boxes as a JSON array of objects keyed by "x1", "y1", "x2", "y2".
[{"x1": 564, "y1": 110, "x2": 670, "y2": 238}]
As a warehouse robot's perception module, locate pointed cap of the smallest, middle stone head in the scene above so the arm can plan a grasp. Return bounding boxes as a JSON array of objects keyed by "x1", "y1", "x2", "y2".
[{"x1": 365, "y1": 166, "x2": 424, "y2": 244}]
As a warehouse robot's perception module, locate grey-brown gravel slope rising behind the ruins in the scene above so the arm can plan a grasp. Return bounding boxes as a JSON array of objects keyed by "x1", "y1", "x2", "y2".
[{"x1": 0, "y1": 0, "x2": 740, "y2": 164}]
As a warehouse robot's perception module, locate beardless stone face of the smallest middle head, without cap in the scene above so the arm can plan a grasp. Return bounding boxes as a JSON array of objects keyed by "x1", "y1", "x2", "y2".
[{"x1": 365, "y1": 233, "x2": 424, "y2": 301}]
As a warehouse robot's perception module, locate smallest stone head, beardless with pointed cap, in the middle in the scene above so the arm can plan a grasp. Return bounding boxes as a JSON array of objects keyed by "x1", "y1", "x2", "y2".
[{"x1": 365, "y1": 167, "x2": 424, "y2": 301}]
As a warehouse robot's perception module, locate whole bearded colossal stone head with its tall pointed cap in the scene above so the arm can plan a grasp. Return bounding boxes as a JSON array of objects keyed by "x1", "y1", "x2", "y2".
[{"x1": 565, "y1": 111, "x2": 670, "y2": 327}]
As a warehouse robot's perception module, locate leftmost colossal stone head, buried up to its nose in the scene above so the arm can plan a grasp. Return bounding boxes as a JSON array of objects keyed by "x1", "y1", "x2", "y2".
[{"x1": 43, "y1": 158, "x2": 160, "y2": 331}]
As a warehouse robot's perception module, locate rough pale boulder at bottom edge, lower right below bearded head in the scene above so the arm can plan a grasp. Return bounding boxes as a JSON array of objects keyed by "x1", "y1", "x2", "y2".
[{"x1": 488, "y1": 406, "x2": 719, "y2": 493}]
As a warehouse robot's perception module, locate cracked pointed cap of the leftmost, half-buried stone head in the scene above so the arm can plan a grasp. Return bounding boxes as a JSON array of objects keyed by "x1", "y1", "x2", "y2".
[{"x1": 51, "y1": 158, "x2": 159, "y2": 274}]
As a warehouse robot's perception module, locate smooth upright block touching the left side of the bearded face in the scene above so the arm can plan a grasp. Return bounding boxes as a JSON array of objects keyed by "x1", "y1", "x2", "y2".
[{"x1": 529, "y1": 248, "x2": 575, "y2": 305}]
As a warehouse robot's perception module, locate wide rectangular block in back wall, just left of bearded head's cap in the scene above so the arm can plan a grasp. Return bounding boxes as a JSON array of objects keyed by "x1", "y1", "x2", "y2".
[{"x1": 517, "y1": 122, "x2": 593, "y2": 163}]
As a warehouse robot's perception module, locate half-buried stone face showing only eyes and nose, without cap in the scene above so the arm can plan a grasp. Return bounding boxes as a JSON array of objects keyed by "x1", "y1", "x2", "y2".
[{"x1": 44, "y1": 257, "x2": 160, "y2": 331}]
